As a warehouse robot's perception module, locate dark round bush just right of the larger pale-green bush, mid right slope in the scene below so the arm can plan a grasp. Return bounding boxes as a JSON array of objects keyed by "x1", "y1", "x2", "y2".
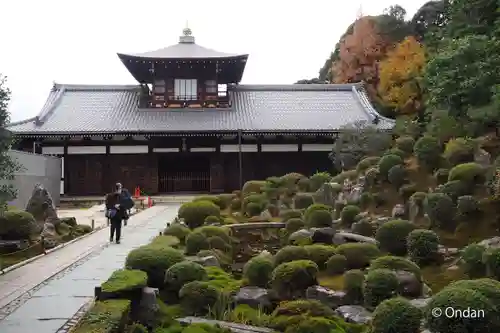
[{"x1": 406, "y1": 229, "x2": 439, "y2": 265}]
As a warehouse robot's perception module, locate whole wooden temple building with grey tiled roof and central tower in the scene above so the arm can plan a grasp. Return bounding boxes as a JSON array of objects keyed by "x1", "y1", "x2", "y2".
[{"x1": 8, "y1": 28, "x2": 394, "y2": 196}]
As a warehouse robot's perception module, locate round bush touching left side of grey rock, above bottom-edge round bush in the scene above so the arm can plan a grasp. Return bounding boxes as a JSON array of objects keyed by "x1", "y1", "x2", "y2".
[{"x1": 363, "y1": 268, "x2": 399, "y2": 310}]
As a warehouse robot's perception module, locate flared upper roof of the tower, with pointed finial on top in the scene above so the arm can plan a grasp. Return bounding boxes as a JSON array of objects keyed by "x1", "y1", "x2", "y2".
[{"x1": 118, "y1": 28, "x2": 248, "y2": 83}]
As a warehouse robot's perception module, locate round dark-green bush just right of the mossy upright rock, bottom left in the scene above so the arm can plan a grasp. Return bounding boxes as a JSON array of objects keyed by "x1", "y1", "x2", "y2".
[{"x1": 179, "y1": 281, "x2": 220, "y2": 315}]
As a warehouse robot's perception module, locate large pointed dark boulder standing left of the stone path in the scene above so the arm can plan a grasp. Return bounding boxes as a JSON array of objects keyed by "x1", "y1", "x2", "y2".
[{"x1": 26, "y1": 184, "x2": 60, "y2": 225}]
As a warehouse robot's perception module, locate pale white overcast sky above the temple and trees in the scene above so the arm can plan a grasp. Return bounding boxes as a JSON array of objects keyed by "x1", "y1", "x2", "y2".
[{"x1": 0, "y1": 0, "x2": 426, "y2": 121}]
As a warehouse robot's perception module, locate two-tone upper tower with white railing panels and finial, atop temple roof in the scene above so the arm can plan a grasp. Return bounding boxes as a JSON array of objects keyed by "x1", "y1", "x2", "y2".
[{"x1": 118, "y1": 28, "x2": 248, "y2": 108}]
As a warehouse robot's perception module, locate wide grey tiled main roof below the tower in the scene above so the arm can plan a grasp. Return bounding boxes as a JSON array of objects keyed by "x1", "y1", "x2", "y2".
[{"x1": 8, "y1": 84, "x2": 394, "y2": 135}]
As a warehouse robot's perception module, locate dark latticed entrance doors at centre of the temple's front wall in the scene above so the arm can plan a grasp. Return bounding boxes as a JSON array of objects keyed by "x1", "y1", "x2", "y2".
[{"x1": 158, "y1": 154, "x2": 210, "y2": 193}]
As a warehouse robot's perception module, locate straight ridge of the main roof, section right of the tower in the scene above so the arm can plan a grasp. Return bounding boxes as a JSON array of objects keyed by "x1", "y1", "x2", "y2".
[{"x1": 229, "y1": 83, "x2": 360, "y2": 91}]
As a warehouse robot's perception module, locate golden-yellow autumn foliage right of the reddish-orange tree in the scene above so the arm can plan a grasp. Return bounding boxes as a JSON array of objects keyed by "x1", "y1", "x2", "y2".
[{"x1": 378, "y1": 36, "x2": 425, "y2": 114}]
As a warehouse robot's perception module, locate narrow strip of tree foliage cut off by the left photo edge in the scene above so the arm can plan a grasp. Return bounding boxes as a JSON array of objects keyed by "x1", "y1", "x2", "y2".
[{"x1": 0, "y1": 74, "x2": 20, "y2": 213}]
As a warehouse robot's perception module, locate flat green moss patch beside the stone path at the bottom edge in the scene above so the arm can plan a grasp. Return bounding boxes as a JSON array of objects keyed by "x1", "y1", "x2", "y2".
[{"x1": 73, "y1": 299, "x2": 130, "y2": 333}]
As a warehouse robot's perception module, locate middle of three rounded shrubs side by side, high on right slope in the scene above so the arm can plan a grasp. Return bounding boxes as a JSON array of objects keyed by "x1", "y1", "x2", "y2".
[{"x1": 424, "y1": 193, "x2": 456, "y2": 231}]
